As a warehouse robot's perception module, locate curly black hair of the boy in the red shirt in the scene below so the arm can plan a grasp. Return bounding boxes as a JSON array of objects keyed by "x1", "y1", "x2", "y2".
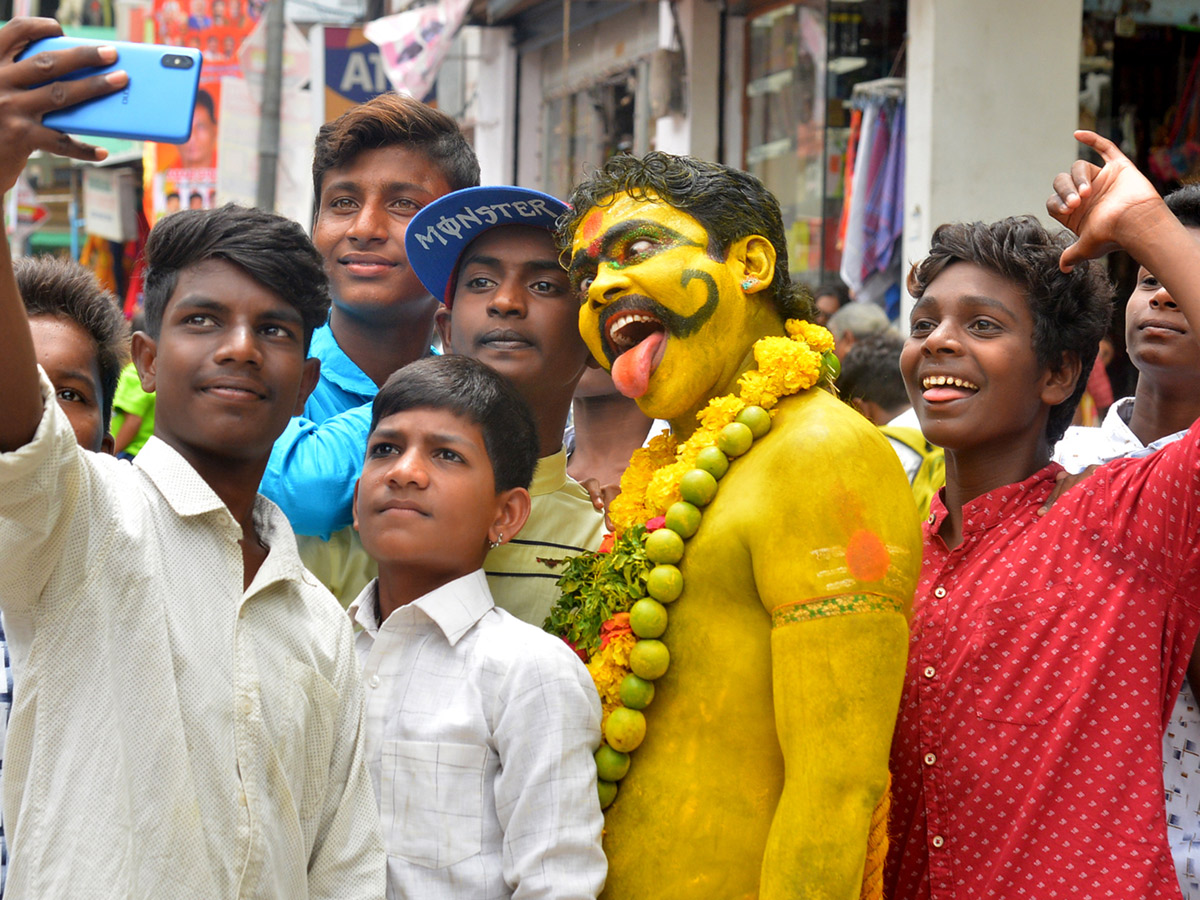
[{"x1": 908, "y1": 216, "x2": 1112, "y2": 444}]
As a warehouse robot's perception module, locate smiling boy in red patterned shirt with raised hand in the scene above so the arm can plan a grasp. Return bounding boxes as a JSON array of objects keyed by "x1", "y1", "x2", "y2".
[{"x1": 887, "y1": 132, "x2": 1200, "y2": 900}]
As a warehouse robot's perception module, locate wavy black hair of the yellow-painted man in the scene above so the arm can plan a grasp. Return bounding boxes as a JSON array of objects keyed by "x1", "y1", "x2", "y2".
[{"x1": 558, "y1": 150, "x2": 815, "y2": 320}]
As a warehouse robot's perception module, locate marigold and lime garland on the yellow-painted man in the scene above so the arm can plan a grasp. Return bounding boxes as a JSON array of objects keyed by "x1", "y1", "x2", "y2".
[{"x1": 545, "y1": 319, "x2": 838, "y2": 808}]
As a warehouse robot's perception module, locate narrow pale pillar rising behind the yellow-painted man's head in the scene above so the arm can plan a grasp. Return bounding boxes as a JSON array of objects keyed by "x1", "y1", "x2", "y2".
[{"x1": 654, "y1": 0, "x2": 721, "y2": 161}]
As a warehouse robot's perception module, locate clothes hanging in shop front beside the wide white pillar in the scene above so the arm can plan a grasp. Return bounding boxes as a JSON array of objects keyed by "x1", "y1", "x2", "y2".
[{"x1": 840, "y1": 78, "x2": 905, "y2": 319}]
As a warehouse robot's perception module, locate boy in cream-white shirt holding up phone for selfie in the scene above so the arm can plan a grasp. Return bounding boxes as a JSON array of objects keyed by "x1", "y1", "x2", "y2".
[{"x1": 0, "y1": 19, "x2": 384, "y2": 900}]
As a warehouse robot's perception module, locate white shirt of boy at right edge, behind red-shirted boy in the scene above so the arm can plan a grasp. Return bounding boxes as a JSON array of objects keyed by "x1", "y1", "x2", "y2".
[{"x1": 1054, "y1": 397, "x2": 1200, "y2": 900}]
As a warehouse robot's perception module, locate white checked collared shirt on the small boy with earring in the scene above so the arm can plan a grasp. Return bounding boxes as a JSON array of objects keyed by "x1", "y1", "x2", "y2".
[{"x1": 350, "y1": 570, "x2": 607, "y2": 900}]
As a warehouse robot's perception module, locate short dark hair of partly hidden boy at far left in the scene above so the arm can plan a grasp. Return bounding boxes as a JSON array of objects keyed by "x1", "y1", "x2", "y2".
[{"x1": 12, "y1": 256, "x2": 130, "y2": 432}]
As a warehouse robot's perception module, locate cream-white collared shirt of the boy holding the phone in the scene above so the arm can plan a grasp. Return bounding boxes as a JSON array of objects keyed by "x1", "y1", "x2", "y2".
[{"x1": 0, "y1": 373, "x2": 385, "y2": 900}]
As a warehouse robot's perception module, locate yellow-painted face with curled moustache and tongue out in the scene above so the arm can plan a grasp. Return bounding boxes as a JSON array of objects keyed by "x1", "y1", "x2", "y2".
[{"x1": 569, "y1": 193, "x2": 754, "y2": 420}]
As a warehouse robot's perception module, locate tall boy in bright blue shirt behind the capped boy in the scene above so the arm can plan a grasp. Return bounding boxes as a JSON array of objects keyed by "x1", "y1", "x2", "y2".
[{"x1": 262, "y1": 92, "x2": 479, "y2": 535}]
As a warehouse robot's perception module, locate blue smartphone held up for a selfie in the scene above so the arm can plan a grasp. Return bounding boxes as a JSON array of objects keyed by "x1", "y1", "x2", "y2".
[{"x1": 17, "y1": 37, "x2": 202, "y2": 144}]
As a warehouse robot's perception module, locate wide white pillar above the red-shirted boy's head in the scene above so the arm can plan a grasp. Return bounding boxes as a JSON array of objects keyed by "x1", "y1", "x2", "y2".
[{"x1": 904, "y1": 0, "x2": 1082, "y2": 314}]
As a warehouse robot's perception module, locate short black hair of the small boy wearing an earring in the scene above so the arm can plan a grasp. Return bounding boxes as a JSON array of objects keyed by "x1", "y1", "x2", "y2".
[{"x1": 371, "y1": 355, "x2": 538, "y2": 493}]
